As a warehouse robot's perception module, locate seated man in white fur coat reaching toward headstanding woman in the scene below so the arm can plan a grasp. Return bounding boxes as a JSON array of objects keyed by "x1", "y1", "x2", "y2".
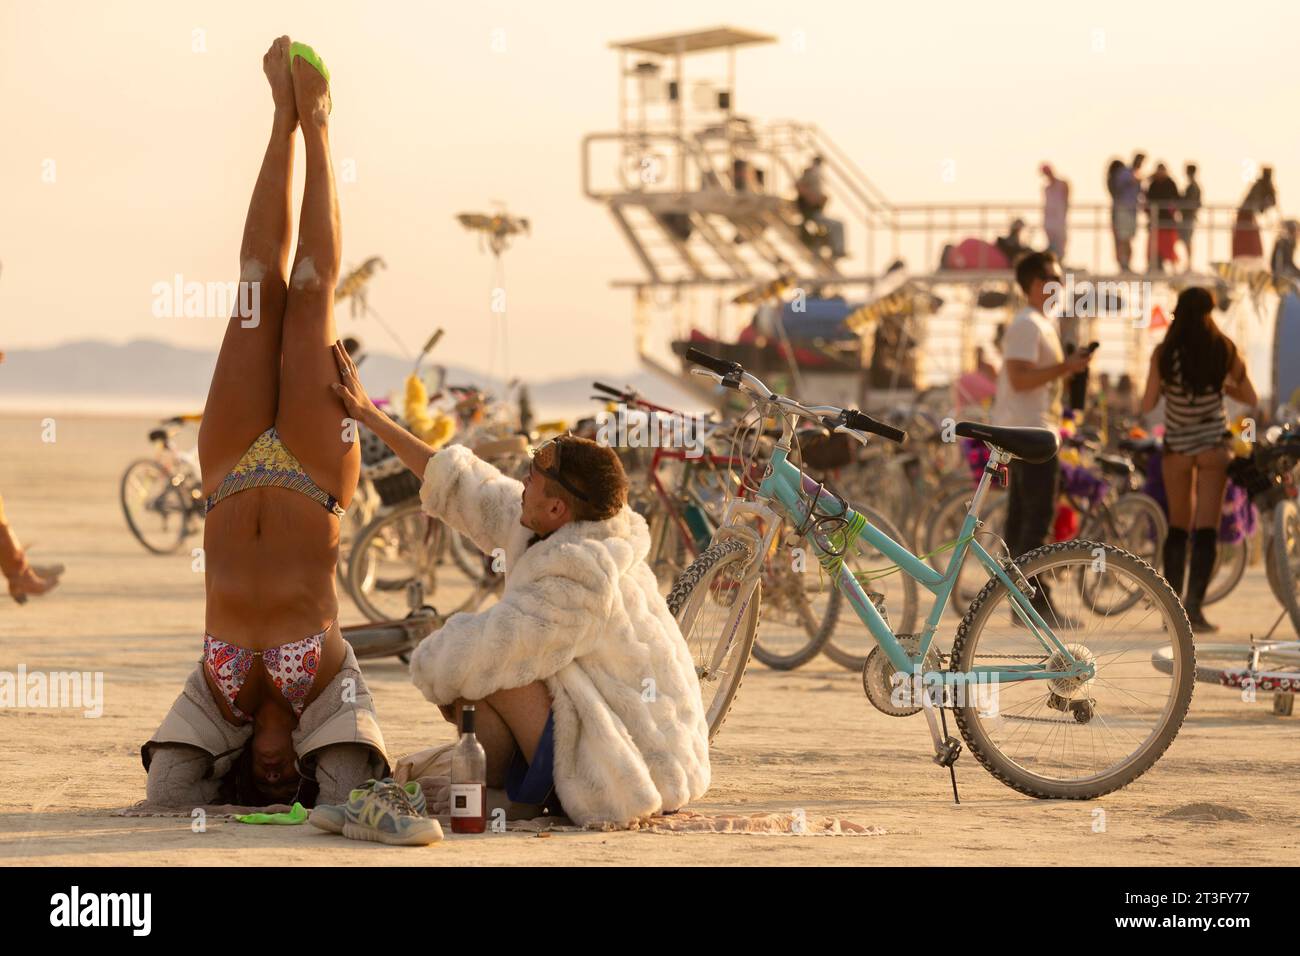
[{"x1": 334, "y1": 346, "x2": 709, "y2": 826}]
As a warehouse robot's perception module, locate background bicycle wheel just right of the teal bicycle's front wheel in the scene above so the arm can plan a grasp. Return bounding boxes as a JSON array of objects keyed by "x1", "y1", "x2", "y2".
[{"x1": 754, "y1": 538, "x2": 840, "y2": 671}]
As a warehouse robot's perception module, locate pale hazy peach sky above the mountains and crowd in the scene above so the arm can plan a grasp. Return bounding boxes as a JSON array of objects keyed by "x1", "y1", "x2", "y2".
[{"x1": 0, "y1": 0, "x2": 1300, "y2": 377}]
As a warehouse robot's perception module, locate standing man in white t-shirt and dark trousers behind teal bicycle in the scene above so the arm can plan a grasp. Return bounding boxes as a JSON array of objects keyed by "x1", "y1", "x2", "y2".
[{"x1": 992, "y1": 252, "x2": 1092, "y2": 600}]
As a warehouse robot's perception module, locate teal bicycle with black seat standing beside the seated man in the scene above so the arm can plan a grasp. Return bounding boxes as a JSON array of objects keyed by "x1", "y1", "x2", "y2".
[{"x1": 668, "y1": 349, "x2": 1196, "y2": 800}]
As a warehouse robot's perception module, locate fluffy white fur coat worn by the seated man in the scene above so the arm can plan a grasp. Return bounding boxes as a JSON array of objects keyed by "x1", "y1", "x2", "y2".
[{"x1": 411, "y1": 445, "x2": 709, "y2": 826}]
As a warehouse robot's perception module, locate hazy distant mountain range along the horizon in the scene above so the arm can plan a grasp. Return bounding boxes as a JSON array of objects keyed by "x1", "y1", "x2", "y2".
[{"x1": 0, "y1": 339, "x2": 699, "y2": 416}]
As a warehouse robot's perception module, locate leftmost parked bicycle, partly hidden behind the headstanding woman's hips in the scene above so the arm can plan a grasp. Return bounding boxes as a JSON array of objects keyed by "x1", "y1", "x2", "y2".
[{"x1": 118, "y1": 415, "x2": 204, "y2": 554}]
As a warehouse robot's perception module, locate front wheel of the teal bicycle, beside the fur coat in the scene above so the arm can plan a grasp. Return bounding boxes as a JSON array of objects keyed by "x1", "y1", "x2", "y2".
[{"x1": 668, "y1": 538, "x2": 763, "y2": 741}]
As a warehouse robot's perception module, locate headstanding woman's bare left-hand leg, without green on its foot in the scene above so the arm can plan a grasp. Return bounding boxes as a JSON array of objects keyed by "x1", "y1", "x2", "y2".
[{"x1": 199, "y1": 36, "x2": 298, "y2": 494}]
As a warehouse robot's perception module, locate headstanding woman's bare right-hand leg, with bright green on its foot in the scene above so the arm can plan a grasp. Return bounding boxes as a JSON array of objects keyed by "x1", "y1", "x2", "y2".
[{"x1": 276, "y1": 59, "x2": 361, "y2": 507}]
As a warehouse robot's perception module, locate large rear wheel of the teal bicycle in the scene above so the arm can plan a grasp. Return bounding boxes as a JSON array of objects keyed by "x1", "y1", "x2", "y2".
[{"x1": 952, "y1": 540, "x2": 1196, "y2": 800}]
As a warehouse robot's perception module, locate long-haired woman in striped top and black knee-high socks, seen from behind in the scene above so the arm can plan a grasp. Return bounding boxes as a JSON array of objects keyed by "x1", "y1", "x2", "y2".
[{"x1": 1141, "y1": 289, "x2": 1258, "y2": 632}]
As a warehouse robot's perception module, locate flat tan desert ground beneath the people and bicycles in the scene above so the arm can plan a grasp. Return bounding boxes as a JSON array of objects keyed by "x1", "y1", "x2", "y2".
[{"x1": 0, "y1": 414, "x2": 1300, "y2": 866}]
